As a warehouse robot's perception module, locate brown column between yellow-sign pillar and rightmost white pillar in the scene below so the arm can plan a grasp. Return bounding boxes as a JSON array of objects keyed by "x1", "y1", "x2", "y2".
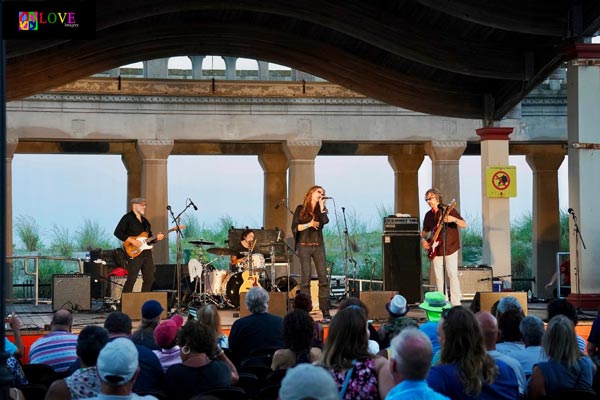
[{"x1": 525, "y1": 145, "x2": 565, "y2": 297}]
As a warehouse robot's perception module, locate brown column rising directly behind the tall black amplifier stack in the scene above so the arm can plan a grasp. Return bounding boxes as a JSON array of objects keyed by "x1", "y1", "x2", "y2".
[{"x1": 388, "y1": 144, "x2": 425, "y2": 218}]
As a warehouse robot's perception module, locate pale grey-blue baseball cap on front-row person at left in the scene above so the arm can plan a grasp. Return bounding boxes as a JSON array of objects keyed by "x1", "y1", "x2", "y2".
[{"x1": 96, "y1": 338, "x2": 138, "y2": 386}]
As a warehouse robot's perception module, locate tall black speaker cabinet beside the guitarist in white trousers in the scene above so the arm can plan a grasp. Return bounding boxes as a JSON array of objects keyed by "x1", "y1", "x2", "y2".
[{"x1": 382, "y1": 233, "x2": 422, "y2": 304}]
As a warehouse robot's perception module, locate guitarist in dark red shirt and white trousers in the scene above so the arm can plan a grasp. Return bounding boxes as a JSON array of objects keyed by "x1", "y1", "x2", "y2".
[{"x1": 421, "y1": 188, "x2": 467, "y2": 306}]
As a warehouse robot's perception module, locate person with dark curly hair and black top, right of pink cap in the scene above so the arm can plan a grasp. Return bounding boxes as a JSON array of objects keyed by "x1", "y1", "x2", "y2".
[{"x1": 166, "y1": 321, "x2": 231, "y2": 399}]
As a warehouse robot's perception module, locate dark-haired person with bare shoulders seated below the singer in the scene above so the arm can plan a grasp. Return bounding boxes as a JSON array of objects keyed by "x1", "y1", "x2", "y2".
[{"x1": 271, "y1": 309, "x2": 321, "y2": 371}]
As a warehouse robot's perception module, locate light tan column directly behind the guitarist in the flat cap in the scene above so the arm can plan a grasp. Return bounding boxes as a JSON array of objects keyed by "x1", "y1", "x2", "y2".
[{"x1": 137, "y1": 140, "x2": 174, "y2": 264}]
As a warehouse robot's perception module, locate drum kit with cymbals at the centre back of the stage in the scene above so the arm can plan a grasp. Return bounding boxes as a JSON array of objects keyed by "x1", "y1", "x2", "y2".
[{"x1": 188, "y1": 240, "x2": 297, "y2": 308}]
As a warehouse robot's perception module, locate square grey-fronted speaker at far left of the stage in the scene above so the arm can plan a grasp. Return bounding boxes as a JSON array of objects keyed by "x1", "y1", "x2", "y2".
[{"x1": 52, "y1": 274, "x2": 92, "y2": 311}]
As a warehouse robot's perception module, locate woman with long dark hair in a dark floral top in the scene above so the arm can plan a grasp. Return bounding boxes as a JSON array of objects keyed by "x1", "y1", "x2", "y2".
[{"x1": 321, "y1": 305, "x2": 393, "y2": 400}]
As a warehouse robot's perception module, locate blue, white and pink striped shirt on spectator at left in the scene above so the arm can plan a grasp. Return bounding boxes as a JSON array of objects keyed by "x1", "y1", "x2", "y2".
[{"x1": 29, "y1": 331, "x2": 77, "y2": 372}]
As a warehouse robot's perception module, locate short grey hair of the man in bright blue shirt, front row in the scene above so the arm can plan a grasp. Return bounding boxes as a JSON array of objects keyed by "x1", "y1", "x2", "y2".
[{"x1": 390, "y1": 327, "x2": 433, "y2": 381}]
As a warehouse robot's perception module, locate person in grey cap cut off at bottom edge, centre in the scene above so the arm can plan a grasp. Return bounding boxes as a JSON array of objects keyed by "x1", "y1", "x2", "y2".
[{"x1": 279, "y1": 364, "x2": 339, "y2": 400}]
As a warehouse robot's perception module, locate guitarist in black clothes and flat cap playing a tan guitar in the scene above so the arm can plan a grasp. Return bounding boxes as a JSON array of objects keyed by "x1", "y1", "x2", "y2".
[{"x1": 114, "y1": 197, "x2": 165, "y2": 293}]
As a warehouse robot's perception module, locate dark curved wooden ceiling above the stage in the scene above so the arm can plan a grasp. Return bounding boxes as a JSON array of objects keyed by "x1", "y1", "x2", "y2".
[{"x1": 6, "y1": 0, "x2": 600, "y2": 122}]
